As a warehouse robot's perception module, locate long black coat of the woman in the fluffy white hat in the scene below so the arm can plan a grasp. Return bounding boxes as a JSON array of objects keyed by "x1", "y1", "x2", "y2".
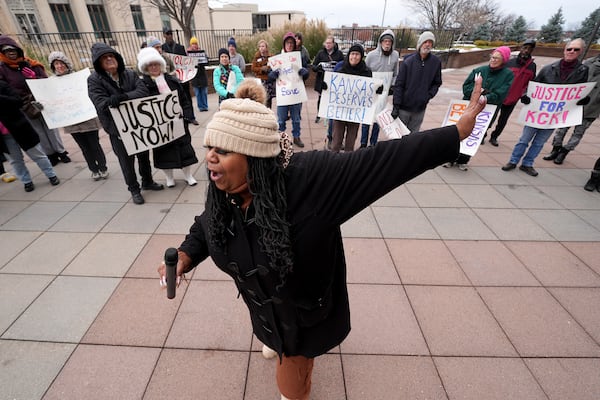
[{"x1": 142, "y1": 74, "x2": 198, "y2": 169}]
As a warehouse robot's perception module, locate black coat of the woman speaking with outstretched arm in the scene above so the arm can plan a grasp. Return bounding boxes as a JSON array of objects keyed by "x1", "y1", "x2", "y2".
[{"x1": 180, "y1": 126, "x2": 459, "y2": 357}]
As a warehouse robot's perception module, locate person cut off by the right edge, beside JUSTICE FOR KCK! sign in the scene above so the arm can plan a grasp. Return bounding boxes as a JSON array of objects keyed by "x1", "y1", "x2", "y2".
[{"x1": 544, "y1": 51, "x2": 600, "y2": 165}]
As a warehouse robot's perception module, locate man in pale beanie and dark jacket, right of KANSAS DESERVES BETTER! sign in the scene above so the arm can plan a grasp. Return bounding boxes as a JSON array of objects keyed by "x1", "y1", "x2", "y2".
[{"x1": 392, "y1": 31, "x2": 442, "y2": 132}]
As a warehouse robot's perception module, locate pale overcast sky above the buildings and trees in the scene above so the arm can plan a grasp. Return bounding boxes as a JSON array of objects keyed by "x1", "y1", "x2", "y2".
[{"x1": 209, "y1": 0, "x2": 598, "y2": 29}]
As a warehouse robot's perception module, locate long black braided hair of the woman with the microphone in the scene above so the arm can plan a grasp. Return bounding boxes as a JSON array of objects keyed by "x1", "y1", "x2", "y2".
[{"x1": 206, "y1": 156, "x2": 293, "y2": 289}]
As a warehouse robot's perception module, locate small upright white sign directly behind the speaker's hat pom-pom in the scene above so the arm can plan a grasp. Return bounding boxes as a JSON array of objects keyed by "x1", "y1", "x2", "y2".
[{"x1": 268, "y1": 51, "x2": 308, "y2": 106}]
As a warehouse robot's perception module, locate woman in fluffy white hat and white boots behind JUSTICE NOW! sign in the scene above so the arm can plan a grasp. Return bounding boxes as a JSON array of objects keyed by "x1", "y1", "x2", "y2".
[{"x1": 137, "y1": 48, "x2": 198, "y2": 188}]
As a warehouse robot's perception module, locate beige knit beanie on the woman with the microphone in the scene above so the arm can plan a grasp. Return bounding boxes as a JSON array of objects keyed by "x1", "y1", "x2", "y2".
[{"x1": 204, "y1": 98, "x2": 281, "y2": 158}]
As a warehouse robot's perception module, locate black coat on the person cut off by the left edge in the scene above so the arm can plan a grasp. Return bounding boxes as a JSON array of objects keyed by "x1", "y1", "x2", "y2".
[{"x1": 0, "y1": 80, "x2": 40, "y2": 153}]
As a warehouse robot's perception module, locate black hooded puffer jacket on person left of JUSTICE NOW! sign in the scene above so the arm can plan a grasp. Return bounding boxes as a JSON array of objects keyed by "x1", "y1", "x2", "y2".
[{"x1": 88, "y1": 43, "x2": 150, "y2": 136}]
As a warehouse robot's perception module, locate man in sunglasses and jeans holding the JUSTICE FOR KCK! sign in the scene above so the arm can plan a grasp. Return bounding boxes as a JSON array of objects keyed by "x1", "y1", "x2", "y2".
[{"x1": 502, "y1": 38, "x2": 589, "y2": 176}]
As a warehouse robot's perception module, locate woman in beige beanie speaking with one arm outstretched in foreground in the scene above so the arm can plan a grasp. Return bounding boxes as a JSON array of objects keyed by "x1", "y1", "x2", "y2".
[{"x1": 157, "y1": 79, "x2": 485, "y2": 400}]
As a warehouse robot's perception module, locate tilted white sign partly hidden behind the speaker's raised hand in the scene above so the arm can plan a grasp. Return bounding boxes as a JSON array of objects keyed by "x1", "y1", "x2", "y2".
[{"x1": 442, "y1": 100, "x2": 496, "y2": 156}]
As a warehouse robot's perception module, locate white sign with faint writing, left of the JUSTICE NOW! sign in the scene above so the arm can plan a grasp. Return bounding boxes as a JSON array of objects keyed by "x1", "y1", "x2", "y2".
[{"x1": 25, "y1": 68, "x2": 96, "y2": 129}]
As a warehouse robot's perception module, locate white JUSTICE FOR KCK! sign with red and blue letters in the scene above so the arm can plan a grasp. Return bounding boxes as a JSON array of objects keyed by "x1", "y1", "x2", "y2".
[{"x1": 518, "y1": 81, "x2": 595, "y2": 129}]
